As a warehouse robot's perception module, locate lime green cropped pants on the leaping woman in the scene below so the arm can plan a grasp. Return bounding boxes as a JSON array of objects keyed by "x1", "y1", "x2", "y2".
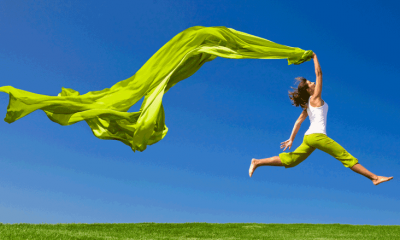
[{"x1": 279, "y1": 133, "x2": 358, "y2": 168}]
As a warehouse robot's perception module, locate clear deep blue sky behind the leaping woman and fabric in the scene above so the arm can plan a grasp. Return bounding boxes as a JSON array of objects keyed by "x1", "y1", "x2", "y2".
[{"x1": 0, "y1": 0, "x2": 400, "y2": 225}]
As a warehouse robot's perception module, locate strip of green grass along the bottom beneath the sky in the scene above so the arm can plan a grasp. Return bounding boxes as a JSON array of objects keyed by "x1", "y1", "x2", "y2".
[{"x1": 0, "y1": 223, "x2": 400, "y2": 240}]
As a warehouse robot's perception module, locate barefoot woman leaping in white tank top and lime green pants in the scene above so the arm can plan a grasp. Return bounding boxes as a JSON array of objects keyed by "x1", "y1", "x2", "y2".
[{"x1": 249, "y1": 53, "x2": 393, "y2": 185}]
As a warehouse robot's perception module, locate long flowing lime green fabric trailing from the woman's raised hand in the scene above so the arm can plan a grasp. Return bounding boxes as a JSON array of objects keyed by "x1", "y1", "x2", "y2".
[{"x1": 0, "y1": 26, "x2": 313, "y2": 151}]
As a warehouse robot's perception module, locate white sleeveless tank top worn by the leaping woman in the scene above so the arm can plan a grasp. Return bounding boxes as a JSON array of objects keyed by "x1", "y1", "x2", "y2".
[{"x1": 304, "y1": 97, "x2": 328, "y2": 135}]
